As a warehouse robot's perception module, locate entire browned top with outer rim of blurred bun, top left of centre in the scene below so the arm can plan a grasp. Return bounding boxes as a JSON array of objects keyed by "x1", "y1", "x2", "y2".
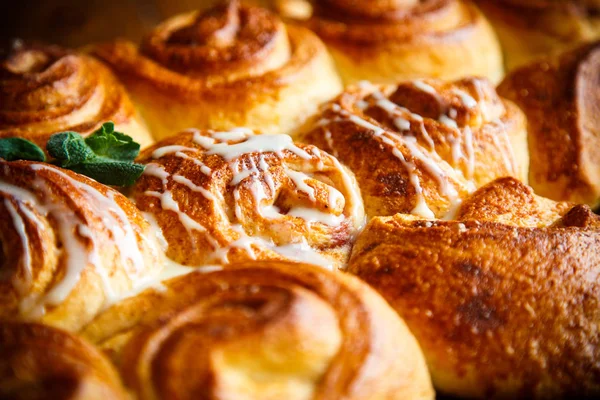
[{"x1": 94, "y1": 0, "x2": 325, "y2": 100}]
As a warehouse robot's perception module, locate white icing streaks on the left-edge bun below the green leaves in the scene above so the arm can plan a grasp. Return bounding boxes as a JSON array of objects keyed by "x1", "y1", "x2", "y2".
[{"x1": 2, "y1": 164, "x2": 157, "y2": 319}]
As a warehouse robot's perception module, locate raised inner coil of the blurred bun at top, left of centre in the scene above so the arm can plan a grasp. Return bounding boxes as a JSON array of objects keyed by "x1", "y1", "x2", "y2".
[{"x1": 140, "y1": 0, "x2": 289, "y2": 80}]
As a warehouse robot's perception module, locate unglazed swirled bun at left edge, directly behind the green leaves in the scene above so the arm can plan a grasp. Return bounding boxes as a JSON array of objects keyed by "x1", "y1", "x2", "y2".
[{"x1": 0, "y1": 42, "x2": 152, "y2": 148}]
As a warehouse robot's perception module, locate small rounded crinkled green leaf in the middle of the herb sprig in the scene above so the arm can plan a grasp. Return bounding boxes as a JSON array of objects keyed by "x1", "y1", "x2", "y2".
[{"x1": 46, "y1": 132, "x2": 95, "y2": 168}]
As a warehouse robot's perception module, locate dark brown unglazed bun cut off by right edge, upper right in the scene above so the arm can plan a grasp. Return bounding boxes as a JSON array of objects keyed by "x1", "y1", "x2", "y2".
[{"x1": 498, "y1": 42, "x2": 600, "y2": 205}]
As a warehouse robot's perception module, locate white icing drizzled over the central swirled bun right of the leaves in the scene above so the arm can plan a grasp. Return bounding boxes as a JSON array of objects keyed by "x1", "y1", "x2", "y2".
[{"x1": 144, "y1": 128, "x2": 365, "y2": 268}]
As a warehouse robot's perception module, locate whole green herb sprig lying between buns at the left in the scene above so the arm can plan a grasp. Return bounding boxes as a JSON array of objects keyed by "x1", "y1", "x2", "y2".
[{"x1": 0, "y1": 122, "x2": 144, "y2": 186}]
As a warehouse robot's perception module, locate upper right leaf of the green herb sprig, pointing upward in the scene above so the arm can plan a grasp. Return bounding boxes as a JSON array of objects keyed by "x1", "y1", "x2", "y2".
[{"x1": 85, "y1": 122, "x2": 140, "y2": 161}]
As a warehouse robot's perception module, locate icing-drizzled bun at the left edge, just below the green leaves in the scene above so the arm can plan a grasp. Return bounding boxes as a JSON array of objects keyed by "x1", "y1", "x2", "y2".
[{"x1": 0, "y1": 161, "x2": 159, "y2": 330}]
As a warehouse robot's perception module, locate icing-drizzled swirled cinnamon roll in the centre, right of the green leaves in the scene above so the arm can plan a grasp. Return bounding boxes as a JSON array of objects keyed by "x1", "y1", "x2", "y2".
[{"x1": 130, "y1": 128, "x2": 364, "y2": 268}]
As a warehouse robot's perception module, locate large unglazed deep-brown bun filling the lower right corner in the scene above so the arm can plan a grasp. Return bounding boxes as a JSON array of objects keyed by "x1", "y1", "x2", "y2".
[{"x1": 349, "y1": 178, "x2": 600, "y2": 399}]
